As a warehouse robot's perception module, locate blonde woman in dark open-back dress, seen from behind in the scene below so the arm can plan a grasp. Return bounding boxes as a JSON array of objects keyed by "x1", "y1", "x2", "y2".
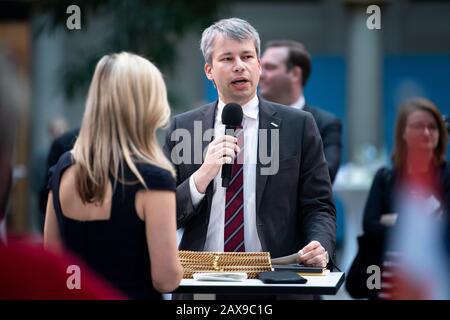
[{"x1": 44, "y1": 53, "x2": 182, "y2": 299}]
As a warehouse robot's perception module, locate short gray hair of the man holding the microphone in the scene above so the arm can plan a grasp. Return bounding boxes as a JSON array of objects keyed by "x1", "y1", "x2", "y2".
[{"x1": 200, "y1": 18, "x2": 261, "y2": 64}]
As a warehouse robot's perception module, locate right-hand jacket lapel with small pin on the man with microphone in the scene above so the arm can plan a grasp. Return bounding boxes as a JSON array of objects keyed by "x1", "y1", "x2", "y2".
[{"x1": 256, "y1": 97, "x2": 281, "y2": 214}]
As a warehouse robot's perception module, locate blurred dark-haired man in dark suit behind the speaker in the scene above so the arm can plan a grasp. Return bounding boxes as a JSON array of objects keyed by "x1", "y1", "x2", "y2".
[{"x1": 260, "y1": 40, "x2": 342, "y2": 183}]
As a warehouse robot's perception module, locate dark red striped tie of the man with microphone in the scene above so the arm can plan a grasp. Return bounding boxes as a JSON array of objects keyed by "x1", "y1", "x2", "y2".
[{"x1": 223, "y1": 127, "x2": 245, "y2": 252}]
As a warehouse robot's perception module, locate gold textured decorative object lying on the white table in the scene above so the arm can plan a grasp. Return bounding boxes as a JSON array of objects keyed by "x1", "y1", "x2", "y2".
[{"x1": 179, "y1": 250, "x2": 272, "y2": 279}]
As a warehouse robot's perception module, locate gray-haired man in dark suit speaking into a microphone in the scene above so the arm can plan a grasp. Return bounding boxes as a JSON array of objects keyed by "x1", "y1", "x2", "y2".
[{"x1": 165, "y1": 18, "x2": 336, "y2": 267}]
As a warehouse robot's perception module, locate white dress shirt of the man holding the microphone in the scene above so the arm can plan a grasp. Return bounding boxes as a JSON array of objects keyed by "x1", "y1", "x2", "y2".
[{"x1": 189, "y1": 95, "x2": 262, "y2": 252}]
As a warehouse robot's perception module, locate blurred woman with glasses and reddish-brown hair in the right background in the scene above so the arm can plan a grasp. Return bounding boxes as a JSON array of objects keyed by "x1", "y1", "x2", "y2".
[{"x1": 346, "y1": 98, "x2": 450, "y2": 299}]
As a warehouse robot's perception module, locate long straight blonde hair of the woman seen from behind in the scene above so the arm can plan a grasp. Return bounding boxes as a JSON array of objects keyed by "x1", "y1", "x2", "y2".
[{"x1": 73, "y1": 52, "x2": 175, "y2": 203}]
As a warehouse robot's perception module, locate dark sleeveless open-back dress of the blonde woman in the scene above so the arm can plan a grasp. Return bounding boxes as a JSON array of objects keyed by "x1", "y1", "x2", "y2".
[{"x1": 49, "y1": 152, "x2": 176, "y2": 299}]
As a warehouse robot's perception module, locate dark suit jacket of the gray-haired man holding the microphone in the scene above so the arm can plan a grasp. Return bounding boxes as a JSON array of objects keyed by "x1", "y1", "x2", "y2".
[{"x1": 164, "y1": 98, "x2": 336, "y2": 257}]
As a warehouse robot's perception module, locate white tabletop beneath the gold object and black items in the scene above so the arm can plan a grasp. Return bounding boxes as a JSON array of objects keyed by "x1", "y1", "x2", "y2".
[{"x1": 174, "y1": 272, "x2": 345, "y2": 295}]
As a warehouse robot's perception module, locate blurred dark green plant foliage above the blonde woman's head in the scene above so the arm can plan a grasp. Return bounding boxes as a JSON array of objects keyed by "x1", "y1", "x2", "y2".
[{"x1": 34, "y1": 0, "x2": 222, "y2": 99}]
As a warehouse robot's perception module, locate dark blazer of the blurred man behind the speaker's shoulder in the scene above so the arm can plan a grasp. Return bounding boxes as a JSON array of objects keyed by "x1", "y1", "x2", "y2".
[{"x1": 303, "y1": 105, "x2": 342, "y2": 184}]
